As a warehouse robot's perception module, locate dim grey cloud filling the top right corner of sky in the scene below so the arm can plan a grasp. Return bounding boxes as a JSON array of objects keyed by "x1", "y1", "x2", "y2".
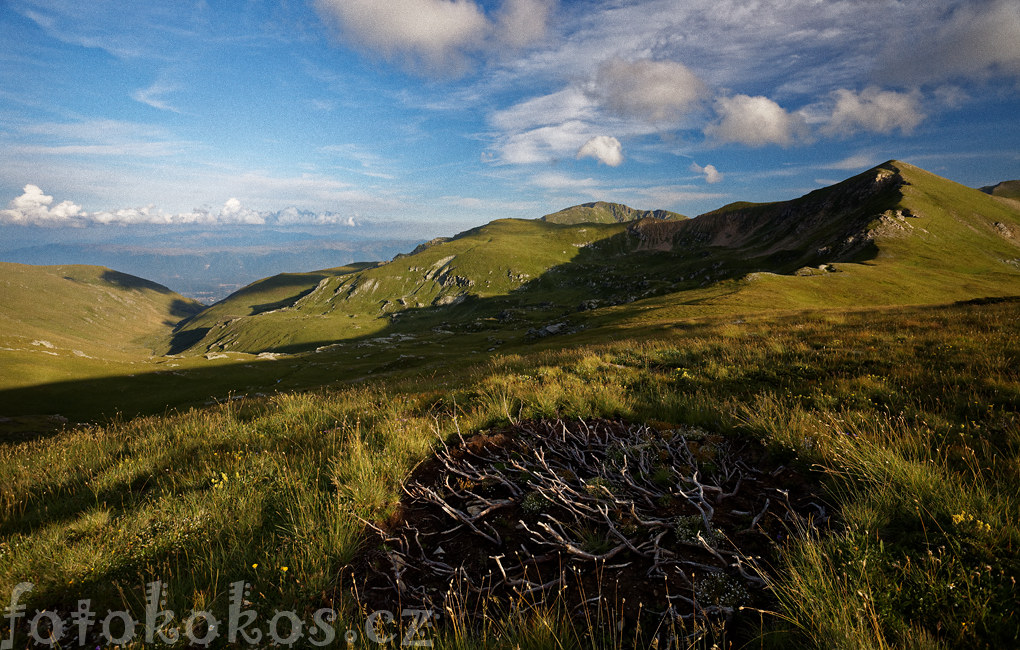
[{"x1": 880, "y1": 0, "x2": 1020, "y2": 84}]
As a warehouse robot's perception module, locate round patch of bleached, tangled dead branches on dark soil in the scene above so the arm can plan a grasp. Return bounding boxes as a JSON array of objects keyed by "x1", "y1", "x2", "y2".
[{"x1": 350, "y1": 419, "x2": 828, "y2": 630}]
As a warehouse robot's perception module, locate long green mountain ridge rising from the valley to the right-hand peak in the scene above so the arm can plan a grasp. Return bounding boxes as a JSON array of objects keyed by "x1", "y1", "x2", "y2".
[{"x1": 174, "y1": 161, "x2": 1020, "y2": 354}]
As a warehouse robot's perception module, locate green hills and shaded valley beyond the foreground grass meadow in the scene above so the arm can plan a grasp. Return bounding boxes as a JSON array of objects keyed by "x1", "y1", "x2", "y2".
[{"x1": 0, "y1": 161, "x2": 1020, "y2": 418}]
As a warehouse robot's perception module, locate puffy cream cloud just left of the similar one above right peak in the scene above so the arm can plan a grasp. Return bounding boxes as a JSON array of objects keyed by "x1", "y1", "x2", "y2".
[{"x1": 705, "y1": 95, "x2": 807, "y2": 147}]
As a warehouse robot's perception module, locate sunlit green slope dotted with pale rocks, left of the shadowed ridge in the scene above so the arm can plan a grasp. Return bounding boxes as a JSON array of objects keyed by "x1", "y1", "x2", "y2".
[{"x1": 172, "y1": 219, "x2": 624, "y2": 353}]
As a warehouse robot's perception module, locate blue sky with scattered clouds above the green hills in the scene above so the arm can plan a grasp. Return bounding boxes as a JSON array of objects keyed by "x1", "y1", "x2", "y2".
[{"x1": 0, "y1": 0, "x2": 1020, "y2": 233}]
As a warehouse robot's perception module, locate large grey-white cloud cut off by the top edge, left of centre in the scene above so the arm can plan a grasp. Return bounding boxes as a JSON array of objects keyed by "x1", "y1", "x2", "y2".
[{"x1": 315, "y1": 0, "x2": 555, "y2": 76}]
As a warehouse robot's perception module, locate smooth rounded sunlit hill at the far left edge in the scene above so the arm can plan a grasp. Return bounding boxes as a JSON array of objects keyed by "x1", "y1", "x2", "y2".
[{"x1": 0, "y1": 262, "x2": 203, "y2": 386}]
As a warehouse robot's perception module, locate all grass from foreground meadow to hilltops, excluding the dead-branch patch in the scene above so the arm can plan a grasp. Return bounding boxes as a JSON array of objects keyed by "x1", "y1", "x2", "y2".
[{"x1": 0, "y1": 163, "x2": 1020, "y2": 648}]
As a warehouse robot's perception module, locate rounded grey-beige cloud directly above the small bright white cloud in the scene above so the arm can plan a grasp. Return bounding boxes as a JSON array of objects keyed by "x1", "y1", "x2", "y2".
[{"x1": 594, "y1": 59, "x2": 706, "y2": 122}]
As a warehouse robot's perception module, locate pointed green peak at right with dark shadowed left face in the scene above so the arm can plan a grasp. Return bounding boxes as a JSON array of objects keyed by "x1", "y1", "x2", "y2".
[{"x1": 612, "y1": 161, "x2": 1020, "y2": 313}]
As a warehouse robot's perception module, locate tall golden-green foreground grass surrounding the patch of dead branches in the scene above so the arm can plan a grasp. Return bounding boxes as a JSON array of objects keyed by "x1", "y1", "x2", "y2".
[{"x1": 0, "y1": 301, "x2": 1020, "y2": 648}]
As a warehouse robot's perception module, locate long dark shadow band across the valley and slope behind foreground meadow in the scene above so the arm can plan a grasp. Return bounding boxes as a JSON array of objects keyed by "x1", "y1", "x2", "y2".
[{"x1": 0, "y1": 223, "x2": 885, "y2": 430}]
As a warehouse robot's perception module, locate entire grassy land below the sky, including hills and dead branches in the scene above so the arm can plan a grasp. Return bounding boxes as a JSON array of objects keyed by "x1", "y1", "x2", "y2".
[{"x1": 0, "y1": 161, "x2": 1020, "y2": 648}]
